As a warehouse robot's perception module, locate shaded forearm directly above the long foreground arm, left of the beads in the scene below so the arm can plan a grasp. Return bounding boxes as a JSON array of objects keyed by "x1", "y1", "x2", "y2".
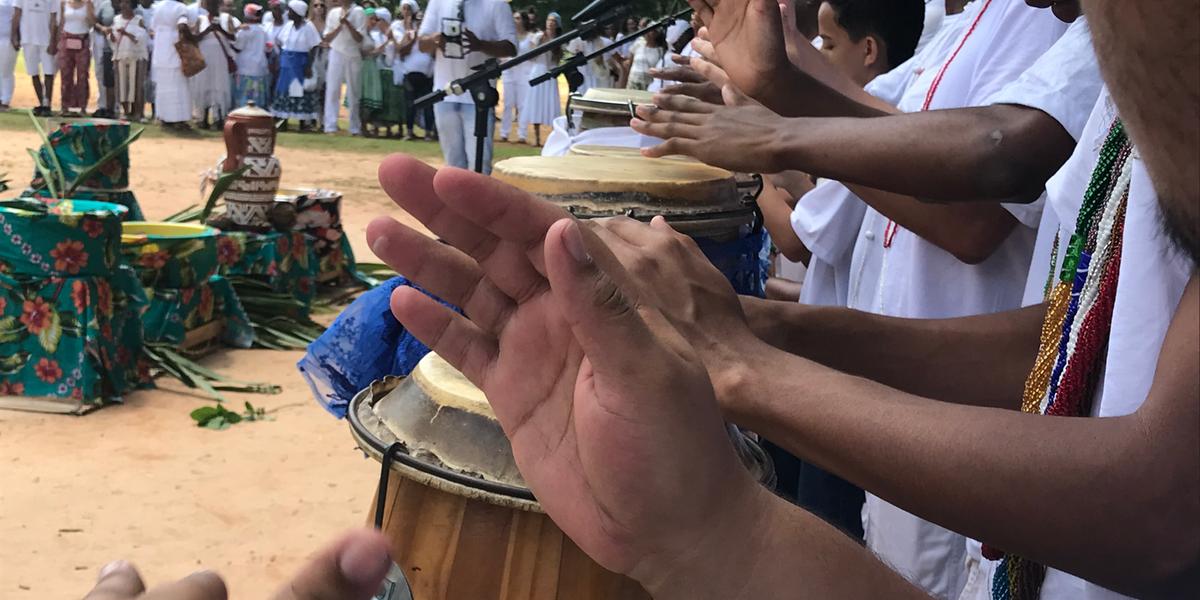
[{"x1": 742, "y1": 296, "x2": 1045, "y2": 410}]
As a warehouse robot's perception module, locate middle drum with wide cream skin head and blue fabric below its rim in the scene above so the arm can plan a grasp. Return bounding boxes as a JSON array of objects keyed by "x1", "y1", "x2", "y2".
[{"x1": 492, "y1": 155, "x2": 767, "y2": 296}]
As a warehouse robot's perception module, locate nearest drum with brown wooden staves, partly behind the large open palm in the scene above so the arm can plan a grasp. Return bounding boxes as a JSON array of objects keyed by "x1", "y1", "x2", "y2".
[{"x1": 348, "y1": 353, "x2": 773, "y2": 600}]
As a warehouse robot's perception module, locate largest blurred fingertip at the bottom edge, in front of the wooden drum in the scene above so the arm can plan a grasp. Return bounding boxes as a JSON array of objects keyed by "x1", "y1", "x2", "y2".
[{"x1": 274, "y1": 529, "x2": 391, "y2": 600}]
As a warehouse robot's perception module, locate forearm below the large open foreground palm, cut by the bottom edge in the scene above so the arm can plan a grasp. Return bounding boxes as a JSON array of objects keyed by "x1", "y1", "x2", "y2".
[{"x1": 643, "y1": 491, "x2": 929, "y2": 600}]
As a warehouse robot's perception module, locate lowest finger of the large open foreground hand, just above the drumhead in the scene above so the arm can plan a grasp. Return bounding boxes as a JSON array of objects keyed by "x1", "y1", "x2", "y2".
[{"x1": 391, "y1": 287, "x2": 499, "y2": 389}]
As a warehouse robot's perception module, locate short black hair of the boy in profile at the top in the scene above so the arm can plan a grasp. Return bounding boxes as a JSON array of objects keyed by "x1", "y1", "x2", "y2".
[{"x1": 824, "y1": 0, "x2": 925, "y2": 70}]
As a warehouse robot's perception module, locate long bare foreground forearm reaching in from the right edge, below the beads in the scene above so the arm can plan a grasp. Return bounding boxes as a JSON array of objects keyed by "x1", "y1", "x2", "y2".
[{"x1": 733, "y1": 337, "x2": 1200, "y2": 595}]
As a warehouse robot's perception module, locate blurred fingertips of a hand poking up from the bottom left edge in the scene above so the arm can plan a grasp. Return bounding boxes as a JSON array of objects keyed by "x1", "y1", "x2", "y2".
[{"x1": 84, "y1": 530, "x2": 391, "y2": 600}]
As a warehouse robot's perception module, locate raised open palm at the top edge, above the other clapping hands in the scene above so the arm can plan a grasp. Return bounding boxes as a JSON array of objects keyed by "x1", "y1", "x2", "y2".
[{"x1": 688, "y1": 0, "x2": 792, "y2": 97}]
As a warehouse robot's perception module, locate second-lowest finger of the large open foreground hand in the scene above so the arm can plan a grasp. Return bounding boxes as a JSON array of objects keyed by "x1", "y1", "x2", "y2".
[{"x1": 367, "y1": 217, "x2": 515, "y2": 332}]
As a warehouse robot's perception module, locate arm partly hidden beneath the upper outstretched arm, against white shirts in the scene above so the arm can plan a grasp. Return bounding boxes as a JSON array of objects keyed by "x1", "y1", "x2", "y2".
[{"x1": 847, "y1": 184, "x2": 1018, "y2": 264}]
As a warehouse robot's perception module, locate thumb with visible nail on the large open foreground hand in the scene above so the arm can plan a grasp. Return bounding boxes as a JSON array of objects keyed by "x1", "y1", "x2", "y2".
[{"x1": 544, "y1": 218, "x2": 654, "y2": 374}]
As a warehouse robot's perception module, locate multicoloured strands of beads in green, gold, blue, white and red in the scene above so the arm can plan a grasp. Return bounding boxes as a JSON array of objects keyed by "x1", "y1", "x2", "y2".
[{"x1": 984, "y1": 120, "x2": 1134, "y2": 600}]
